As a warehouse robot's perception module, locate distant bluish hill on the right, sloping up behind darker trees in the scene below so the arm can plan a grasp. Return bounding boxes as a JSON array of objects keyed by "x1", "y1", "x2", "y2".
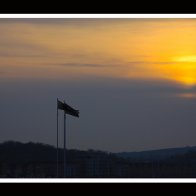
[{"x1": 116, "y1": 146, "x2": 196, "y2": 162}]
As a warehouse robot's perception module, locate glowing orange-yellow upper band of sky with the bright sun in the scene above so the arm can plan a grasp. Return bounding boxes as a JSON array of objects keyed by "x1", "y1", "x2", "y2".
[{"x1": 0, "y1": 19, "x2": 196, "y2": 86}]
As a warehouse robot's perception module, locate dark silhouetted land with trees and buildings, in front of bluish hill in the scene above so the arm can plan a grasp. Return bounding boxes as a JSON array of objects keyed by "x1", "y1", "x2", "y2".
[{"x1": 0, "y1": 141, "x2": 196, "y2": 178}]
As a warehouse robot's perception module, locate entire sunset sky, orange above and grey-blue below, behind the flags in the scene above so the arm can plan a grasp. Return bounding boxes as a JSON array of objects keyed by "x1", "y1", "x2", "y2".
[{"x1": 0, "y1": 18, "x2": 196, "y2": 152}]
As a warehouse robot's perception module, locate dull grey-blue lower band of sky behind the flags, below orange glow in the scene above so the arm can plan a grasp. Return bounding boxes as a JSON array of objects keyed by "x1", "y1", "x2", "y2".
[{"x1": 0, "y1": 78, "x2": 196, "y2": 151}]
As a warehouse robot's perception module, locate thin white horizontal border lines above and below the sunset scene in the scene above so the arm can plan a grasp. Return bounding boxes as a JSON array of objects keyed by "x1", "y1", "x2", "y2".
[{"x1": 0, "y1": 14, "x2": 196, "y2": 183}]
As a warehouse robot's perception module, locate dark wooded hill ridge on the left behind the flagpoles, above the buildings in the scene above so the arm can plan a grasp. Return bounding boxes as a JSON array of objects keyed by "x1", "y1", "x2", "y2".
[{"x1": 0, "y1": 141, "x2": 113, "y2": 164}]
